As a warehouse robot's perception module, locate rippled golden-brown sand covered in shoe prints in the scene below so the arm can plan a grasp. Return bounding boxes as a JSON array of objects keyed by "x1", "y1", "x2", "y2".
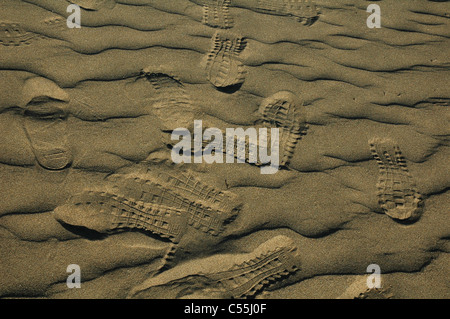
[{"x1": 0, "y1": 0, "x2": 450, "y2": 298}]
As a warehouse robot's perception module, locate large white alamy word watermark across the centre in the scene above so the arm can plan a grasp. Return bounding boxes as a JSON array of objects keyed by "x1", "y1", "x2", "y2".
[{"x1": 171, "y1": 120, "x2": 280, "y2": 174}]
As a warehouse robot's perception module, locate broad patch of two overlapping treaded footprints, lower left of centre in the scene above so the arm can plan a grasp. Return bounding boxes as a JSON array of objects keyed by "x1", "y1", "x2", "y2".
[{"x1": 55, "y1": 166, "x2": 240, "y2": 242}]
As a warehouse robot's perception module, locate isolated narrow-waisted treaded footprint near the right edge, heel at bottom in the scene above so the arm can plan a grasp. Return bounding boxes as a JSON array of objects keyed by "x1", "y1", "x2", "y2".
[{"x1": 369, "y1": 138, "x2": 422, "y2": 220}]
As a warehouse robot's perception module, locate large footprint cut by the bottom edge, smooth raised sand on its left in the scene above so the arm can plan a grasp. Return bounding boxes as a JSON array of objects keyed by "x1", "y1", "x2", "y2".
[{"x1": 129, "y1": 236, "x2": 299, "y2": 299}]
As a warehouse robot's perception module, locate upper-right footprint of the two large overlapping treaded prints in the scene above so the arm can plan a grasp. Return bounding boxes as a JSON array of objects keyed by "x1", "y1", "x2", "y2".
[{"x1": 109, "y1": 167, "x2": 240, "y2": 236}]
